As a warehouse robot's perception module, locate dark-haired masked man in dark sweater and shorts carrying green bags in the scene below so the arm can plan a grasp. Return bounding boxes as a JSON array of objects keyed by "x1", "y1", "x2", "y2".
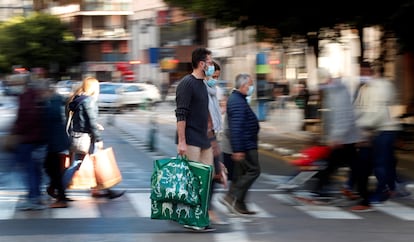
[{"x1": 175, "y1": 48, "x2": 214, "y2": 231}]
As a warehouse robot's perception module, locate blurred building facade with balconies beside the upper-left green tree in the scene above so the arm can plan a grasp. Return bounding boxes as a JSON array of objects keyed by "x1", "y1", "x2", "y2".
[{"x1": 35, "y1": 0, "x2": 135, "y2": 81}]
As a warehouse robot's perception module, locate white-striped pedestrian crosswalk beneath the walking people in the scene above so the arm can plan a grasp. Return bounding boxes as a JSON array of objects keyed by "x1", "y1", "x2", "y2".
[{"x1": 0, "y1": 190, "x2": 414, "y2": 221}]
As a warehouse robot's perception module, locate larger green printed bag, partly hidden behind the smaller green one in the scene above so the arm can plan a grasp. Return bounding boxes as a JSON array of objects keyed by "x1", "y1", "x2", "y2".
[{"x1": 151, "y1": 157, "x2": 213, "y2": 227}]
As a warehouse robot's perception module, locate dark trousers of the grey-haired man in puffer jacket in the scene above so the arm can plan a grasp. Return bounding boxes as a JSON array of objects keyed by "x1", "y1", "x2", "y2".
[{"x1": 229, "y1": 150, "x2": 260, "y2": 203}]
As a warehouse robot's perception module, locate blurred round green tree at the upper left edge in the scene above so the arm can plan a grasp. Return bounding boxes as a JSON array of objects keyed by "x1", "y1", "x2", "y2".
[{"x1": 0, "y1": 13, "x2": 76, "y2": 73}]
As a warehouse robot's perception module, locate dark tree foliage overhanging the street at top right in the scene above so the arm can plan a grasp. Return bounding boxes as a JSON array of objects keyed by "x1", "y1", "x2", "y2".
[{"x1": 164, "y1": 0, "x2": 414, "y2": 55}]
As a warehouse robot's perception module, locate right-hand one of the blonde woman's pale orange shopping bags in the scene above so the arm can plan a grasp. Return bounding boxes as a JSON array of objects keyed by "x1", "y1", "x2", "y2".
[{"x1": 90, "y1": 147, "x2": 122, "y2": 189}]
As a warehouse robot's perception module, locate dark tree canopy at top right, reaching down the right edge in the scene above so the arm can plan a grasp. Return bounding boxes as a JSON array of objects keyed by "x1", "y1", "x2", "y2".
[{"x1": 164, "y1": 0, "x2": 414, "y2": 104}]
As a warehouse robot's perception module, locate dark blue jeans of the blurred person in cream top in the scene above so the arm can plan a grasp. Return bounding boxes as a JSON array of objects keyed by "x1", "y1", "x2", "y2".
[{"x1": 373, "y1": 131, "x2": 397, "y2": 194}]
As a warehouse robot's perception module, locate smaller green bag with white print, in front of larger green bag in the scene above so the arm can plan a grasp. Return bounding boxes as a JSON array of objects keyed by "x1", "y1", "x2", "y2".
[{"x1": 151, "y1": 161, "x2": 200, "y2": 205}]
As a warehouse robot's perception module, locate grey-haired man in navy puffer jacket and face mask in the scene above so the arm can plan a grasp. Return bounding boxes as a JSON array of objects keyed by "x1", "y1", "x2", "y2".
[{"x1": 221, "y1": 74, "x2": 260, "y2": 215}]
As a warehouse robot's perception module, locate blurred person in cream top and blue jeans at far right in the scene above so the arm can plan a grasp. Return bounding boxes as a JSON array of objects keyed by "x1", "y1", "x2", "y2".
[{"x1": 352, "y1": 62, "x2": 402, "y2": 211}]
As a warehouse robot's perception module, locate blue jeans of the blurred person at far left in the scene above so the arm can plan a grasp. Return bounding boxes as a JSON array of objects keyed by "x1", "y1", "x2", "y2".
[{"x1": 16, "y1": 144, "x2": 47, "y2": 202}]
